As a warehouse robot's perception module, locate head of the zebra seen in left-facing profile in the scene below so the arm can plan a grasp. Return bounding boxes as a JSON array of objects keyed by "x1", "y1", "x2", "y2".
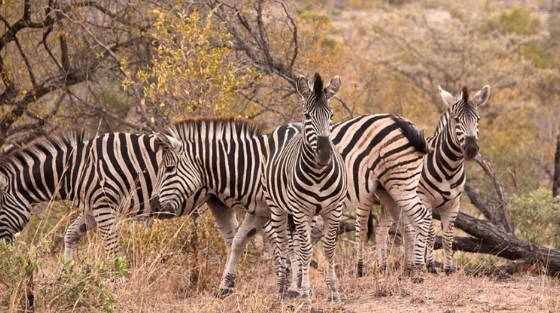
[{"x1": 154, "y1": 130, "x2": 201, "y2": 215}]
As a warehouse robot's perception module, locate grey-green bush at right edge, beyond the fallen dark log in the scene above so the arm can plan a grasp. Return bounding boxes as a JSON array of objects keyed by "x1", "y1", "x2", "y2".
[{"x1": 511, "y1": 188, "x2": 560, "y2": 248}]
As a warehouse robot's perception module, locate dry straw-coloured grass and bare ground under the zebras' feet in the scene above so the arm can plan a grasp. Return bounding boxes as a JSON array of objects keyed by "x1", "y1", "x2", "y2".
[{"x1": 0, "y1": 215, "x2": 560, "y2": 313}]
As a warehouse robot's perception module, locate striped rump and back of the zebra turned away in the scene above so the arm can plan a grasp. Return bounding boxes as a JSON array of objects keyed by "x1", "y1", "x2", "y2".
[{"x1": 331, "y1": 114, "x2": 431, "y2": 207}]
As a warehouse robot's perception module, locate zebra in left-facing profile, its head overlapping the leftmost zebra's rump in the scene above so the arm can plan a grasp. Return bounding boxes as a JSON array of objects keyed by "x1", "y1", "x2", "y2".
[{"x1": 149, "y1": 119, "x2": 298, "y2": 296}]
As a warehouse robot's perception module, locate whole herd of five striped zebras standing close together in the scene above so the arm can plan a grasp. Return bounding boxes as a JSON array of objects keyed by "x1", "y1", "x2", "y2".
[{"x1": 0, "y1": 74, "x2": 490, "y2": 301}]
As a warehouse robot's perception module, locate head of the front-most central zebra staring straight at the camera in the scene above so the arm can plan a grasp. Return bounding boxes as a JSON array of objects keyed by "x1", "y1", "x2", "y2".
[{"x1": 296, "y1": 73, "x2": 340, "y2": 166}]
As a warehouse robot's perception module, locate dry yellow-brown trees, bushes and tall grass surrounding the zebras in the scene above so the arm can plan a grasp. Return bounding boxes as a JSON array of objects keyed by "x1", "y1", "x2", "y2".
[{"x1": 0, "y1": 0, "x2": 560, "y2": 311}]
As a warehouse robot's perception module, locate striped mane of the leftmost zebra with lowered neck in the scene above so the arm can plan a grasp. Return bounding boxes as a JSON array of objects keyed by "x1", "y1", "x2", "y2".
[{"x1": 0, "y1": 131, "x2": 89, "y2": 169}]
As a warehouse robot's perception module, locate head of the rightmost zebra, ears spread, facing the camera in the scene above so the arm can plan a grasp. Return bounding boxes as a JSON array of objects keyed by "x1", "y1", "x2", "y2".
[{"x1": 438, "y1": 85, "x2": 490, "y2": 160}]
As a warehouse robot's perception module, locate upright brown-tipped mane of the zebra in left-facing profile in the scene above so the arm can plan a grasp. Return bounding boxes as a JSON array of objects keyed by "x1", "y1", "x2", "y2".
[{"x1": 163, "y1": 117, "x2": 263, "y2": 141}]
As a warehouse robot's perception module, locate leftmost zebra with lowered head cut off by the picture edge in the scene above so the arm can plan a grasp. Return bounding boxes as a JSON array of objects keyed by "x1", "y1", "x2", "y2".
[{"x1": 0, "y1": 133, "x2": 173, "y2": 261}]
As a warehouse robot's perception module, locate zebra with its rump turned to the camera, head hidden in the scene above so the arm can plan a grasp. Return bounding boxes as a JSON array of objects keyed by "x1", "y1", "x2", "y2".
[{"x1": 264, "y1": 114, "x2": 432, "y2": 284}]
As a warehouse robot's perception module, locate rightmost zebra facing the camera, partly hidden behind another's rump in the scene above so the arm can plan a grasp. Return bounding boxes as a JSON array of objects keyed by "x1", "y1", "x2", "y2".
[{"x1": 376, "y1": 85, "x2": 490, "y2": 274}]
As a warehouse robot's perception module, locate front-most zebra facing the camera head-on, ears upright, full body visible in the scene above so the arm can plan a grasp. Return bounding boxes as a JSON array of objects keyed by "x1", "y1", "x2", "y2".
[{"x1": 263, "y1": 73, "x2": 346, "y2": 301}]
